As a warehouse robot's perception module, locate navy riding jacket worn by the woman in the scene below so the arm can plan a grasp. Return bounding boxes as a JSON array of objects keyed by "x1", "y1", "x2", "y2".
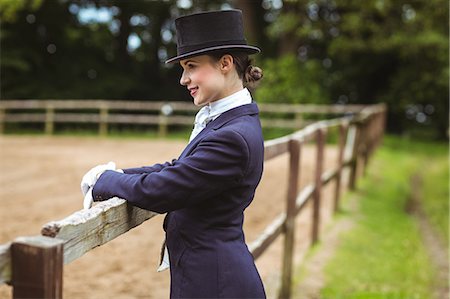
[{"x1": 93, "y1": 103, "x2": 265, "y2": 298}]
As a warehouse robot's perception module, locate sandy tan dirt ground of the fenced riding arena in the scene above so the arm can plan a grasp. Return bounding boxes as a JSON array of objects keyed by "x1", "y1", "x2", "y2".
[{"x1": 0, "y1": 136, "x2": 337, "y2": 299}]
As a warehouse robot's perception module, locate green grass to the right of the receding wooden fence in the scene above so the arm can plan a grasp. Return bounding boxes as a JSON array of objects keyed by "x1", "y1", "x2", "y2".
[{"x1": 321, "y1": 138, "x2": 448, "y2": 299}]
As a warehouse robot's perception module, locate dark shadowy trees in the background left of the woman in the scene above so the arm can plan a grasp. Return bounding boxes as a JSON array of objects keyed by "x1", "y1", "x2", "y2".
[{"x1": 0, "y1": 0, "x2": 187, "y2": 100}]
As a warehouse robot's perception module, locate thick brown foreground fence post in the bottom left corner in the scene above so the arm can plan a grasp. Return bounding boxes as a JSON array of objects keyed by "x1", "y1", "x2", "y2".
[{"x1": 11, "y1": 236, "x2": 64, "y2": 299}]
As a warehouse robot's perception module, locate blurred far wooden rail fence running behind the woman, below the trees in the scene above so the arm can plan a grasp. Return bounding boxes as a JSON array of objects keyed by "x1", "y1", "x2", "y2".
[{"x1": 0, "y1": 100, "x2": 364, "y2": 137}]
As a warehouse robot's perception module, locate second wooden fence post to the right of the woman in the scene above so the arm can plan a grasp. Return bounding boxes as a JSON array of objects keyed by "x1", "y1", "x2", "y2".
[{"x1": 312, "y1": 128, "x2": 326, "y2": 244}]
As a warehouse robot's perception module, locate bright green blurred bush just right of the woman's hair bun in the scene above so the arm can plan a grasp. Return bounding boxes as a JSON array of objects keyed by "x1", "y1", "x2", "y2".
[{"x1": 255, "y1": 55, "x2": 329, "y2": 104}]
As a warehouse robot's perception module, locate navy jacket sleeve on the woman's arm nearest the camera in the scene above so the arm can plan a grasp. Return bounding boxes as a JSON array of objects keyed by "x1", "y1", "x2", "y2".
[{"x1": 93, "y1": 130, "x2": 249, "y2": 213}]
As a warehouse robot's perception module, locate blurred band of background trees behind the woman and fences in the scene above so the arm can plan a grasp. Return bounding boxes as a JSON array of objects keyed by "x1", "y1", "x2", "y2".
[{"x1": 0, "y1": 0, "x2": 449, "y2": 139}]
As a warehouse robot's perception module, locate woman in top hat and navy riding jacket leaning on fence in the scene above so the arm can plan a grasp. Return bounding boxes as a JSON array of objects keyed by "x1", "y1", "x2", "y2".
[{"x1": 82, "y1": 10, "x2": 265, "y2": 298}]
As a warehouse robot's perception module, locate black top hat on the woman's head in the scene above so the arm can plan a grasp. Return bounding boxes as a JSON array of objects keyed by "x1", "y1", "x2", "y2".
[{"x1": 166, "y1": 10, "x2": 261, "y2": 63}]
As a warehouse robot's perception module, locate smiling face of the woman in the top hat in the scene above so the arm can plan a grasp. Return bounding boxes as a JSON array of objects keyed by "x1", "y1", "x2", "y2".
[{"x1": 180, "y1": 55, "x2": 226, "y2": 106}]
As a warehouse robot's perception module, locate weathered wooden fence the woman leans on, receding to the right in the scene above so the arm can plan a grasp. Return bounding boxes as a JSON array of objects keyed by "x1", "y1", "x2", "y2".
[{"x1": 0, "y1": 104, "x2": 386, "y2": 298}]
